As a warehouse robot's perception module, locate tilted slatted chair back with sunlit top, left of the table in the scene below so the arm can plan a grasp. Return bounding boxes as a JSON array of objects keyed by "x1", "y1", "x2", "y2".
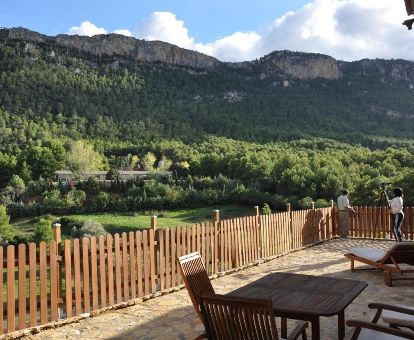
[{"x1": 178, "y1": 251, "x2": 214, "y2": 324}]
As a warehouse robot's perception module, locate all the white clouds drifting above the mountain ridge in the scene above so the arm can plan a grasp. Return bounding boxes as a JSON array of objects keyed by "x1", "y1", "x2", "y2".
[{"x1": 64, "y1": 0, "x2": 414, "y2": 61}]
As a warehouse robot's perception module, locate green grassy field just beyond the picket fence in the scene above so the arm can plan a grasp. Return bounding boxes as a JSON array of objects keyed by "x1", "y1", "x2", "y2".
[{"x1": 12, "y1": 204, "x2": 253, "y2": 234}]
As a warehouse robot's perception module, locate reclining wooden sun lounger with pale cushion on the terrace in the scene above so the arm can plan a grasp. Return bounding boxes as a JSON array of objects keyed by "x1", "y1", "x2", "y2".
[{"x1": 344, "y1": 241, "x2": 414, "y2": 287}]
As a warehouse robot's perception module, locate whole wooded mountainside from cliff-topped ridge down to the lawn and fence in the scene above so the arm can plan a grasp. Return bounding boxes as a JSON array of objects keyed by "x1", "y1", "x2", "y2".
[{"x1": 0, "y1": 29, "x2": 414, "y2": 230}]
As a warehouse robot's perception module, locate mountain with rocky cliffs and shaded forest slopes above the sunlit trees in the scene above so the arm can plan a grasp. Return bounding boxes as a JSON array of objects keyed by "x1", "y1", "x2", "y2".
[{"x1": 0, "y1": 28, "x2": 414, "y2": 143}]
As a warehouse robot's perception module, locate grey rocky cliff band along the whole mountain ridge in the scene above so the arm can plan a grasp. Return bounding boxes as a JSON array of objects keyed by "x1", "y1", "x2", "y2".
[{"x1": 0, "y1": 28, "x2": 414, "y2": 82}]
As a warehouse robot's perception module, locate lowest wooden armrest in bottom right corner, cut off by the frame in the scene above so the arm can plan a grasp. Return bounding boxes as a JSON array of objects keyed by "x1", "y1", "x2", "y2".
[{"x1": 346, "y1": 320, "x2": 414, "y2": 340}]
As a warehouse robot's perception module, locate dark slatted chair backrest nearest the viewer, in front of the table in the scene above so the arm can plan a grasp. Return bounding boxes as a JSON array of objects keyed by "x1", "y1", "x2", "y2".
[{"x1": 201, "y1": 294, "x2": 279, "y2": 340}]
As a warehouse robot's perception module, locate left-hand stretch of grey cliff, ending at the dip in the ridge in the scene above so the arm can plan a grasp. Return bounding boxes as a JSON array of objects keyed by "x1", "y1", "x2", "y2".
[{"x1": 0, "y1": 28, "x2": 220, "y2": 70}]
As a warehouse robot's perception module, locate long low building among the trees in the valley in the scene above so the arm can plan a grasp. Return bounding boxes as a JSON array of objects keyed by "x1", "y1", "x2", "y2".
[{"x1": 55, "y1": 170, "x2": 172, "y2": 182}]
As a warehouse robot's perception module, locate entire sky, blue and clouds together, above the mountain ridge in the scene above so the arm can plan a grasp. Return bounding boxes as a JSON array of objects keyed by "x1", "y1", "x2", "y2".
[{"x1": 0, "y1": 0, "x2": 414, "y2": 61}]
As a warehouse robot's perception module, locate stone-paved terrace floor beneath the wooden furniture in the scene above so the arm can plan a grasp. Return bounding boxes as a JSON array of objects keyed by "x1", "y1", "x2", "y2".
[{"x1": 26, "y1": 240, "x2": 414, "y2": 339}]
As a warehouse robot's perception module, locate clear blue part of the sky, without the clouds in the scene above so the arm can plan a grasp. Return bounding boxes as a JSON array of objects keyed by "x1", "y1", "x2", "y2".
[{"x1": 0, "y1": 0, "x2": 309, "y2": 43}]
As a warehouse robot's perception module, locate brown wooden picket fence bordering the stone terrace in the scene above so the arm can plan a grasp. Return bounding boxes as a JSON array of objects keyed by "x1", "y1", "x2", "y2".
[{"x1": 0, "y1": 207, "x2": 414, "y2": 334}]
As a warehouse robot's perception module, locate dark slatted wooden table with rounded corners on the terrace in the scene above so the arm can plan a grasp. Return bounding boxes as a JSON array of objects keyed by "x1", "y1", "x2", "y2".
[{"x1": 227, "y1": 273, "x2": 368, "y2": 340}]
